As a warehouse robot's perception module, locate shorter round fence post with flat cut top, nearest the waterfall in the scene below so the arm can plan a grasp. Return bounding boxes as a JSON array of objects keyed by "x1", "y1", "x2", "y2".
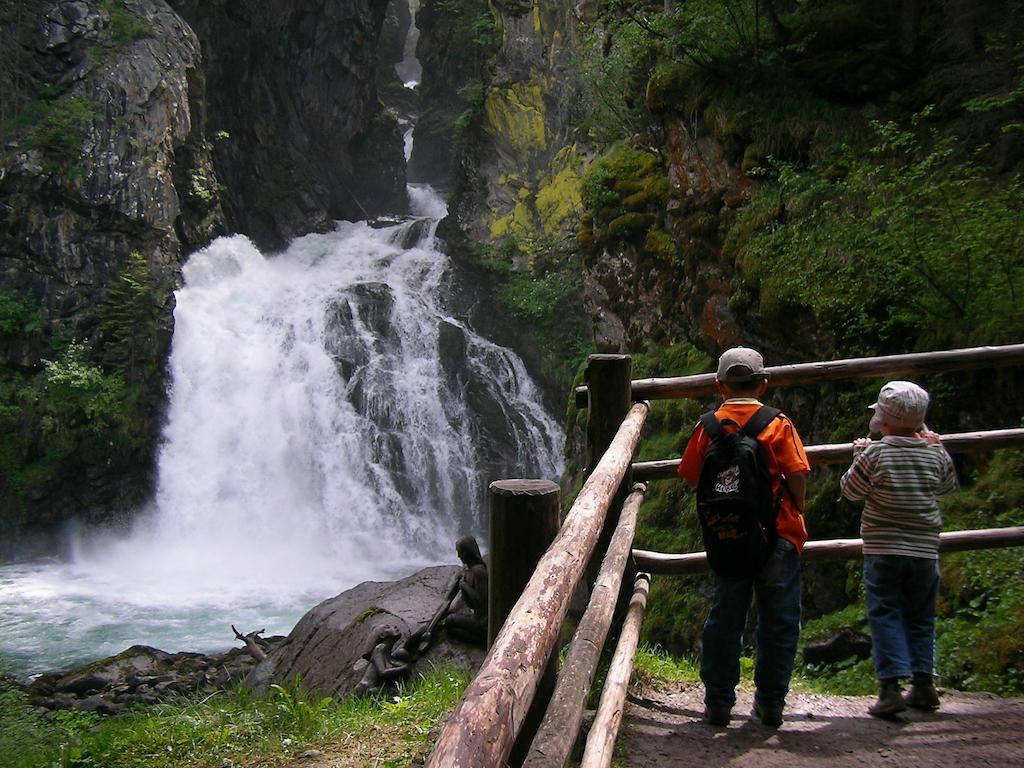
[{"x1": 487, "y1": 479, "x2": 559, "y2": 766}]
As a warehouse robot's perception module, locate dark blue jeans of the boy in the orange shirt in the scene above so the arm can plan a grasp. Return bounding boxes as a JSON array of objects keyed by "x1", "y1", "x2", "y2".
[{"x1": 700, "y1": 539, "x2": 800, "y2": 709}]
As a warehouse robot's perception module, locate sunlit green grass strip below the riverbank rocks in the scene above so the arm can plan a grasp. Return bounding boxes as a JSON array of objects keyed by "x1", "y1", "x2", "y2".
[{"x1": 0, "y1": 669, "x2": 468, "y2": 768}]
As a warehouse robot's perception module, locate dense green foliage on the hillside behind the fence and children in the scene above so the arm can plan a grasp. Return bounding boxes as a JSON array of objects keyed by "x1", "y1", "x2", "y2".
[{"x1": 579, "y1": 0, "x2": 1024, "y2": 693}]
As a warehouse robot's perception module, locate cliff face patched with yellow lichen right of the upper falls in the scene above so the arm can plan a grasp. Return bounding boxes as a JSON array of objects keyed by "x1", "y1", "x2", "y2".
[{"x1": 410, "y1": 0, "x2": 582, "y2": 242}]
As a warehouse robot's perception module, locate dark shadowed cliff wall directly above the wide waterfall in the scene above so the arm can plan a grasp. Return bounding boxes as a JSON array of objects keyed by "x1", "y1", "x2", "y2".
[{"x1": 171, "y1": 0, "x2": 408, "y2": 249}]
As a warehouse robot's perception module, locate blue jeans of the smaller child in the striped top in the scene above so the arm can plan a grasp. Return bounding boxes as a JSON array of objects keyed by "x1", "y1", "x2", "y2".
[{"x1": 864, "y1": 555, "x2": 939, "y2": 680}]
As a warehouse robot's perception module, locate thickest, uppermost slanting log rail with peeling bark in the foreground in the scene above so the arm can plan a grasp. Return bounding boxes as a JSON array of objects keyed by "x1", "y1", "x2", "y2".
[{"x1": 426, "y1": 402, "x2": 648, "y2": 768}]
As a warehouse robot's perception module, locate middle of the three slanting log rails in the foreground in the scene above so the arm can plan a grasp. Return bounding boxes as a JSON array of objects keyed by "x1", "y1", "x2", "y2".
[{"x1": 522, "y1": 484, "x2": 646, "y2": 768}]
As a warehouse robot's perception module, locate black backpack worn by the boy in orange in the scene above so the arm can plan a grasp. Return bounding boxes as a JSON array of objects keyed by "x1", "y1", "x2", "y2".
[{"x1": 696, "y1": 406, "x2": 781, "y2": 577}]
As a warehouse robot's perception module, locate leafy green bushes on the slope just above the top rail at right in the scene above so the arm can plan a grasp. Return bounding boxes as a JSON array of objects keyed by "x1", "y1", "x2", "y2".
[{"x1": 725, "y1": 111, "x2": 1024, "y2": 351}]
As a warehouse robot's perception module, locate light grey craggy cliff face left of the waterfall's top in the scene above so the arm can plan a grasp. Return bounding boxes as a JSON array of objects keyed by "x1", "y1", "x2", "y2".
[{"x1": 0, "y1": 1, "x2": 212, "y2": 367}]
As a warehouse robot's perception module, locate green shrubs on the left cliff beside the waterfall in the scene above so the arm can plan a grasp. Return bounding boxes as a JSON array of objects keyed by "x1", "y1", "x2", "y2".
[{"x1": 0, "y1": 253, "x2": 160, "y2": 524}]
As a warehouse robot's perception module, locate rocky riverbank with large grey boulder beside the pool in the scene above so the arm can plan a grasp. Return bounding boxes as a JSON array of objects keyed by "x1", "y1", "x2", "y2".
[{"x1": 9, "y1": 565, "x2": 483, "y2": 715}]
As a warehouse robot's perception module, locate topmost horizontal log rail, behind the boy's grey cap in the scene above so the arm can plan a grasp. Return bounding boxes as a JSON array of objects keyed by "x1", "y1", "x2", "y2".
[{"x1": 575, "y1": 344, "x2": 1024, "y2": 409}]
